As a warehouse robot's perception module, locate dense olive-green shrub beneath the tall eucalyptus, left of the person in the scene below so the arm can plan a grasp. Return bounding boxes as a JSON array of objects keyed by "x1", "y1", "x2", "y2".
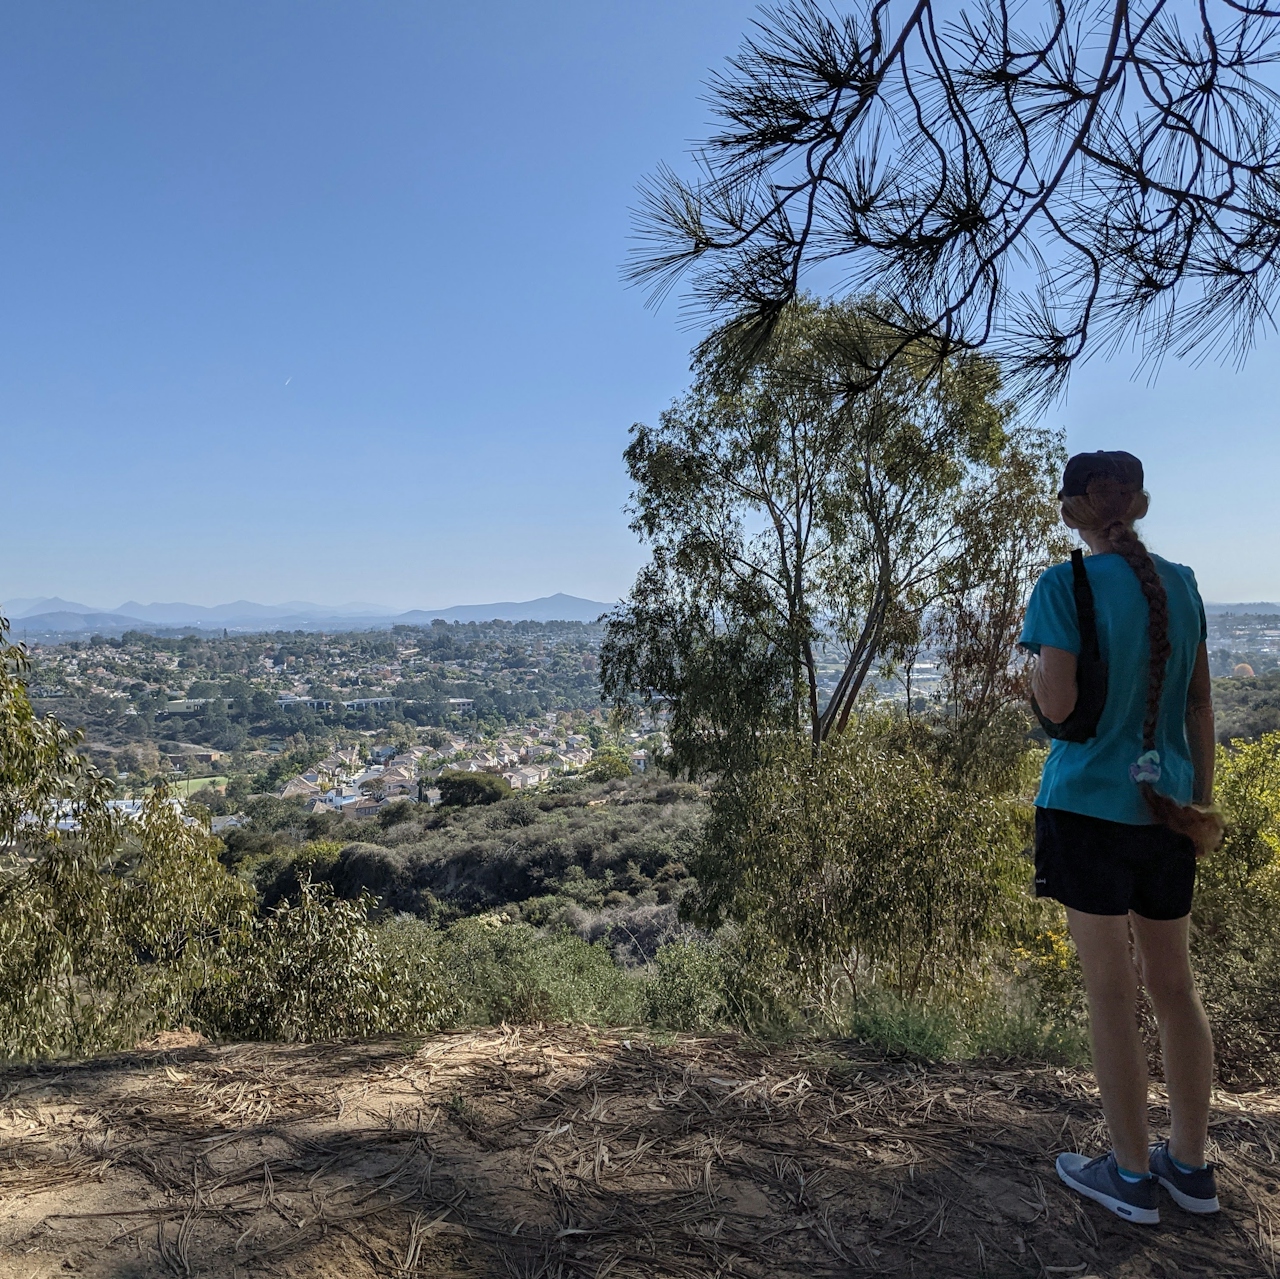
[{"x1": 687, "y1": 718, "x2": 1029, "y2": 1008}]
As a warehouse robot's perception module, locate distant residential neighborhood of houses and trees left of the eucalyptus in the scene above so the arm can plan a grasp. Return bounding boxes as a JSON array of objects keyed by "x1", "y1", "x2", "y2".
[{"x1": 17, "y1": 621, "x2": 655, "y2": 814}]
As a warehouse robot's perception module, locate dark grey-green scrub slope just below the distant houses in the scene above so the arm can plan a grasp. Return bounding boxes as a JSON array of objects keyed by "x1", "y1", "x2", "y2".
[{"x1": 224, "y1": 776, "x2": 704, "y2": 942}]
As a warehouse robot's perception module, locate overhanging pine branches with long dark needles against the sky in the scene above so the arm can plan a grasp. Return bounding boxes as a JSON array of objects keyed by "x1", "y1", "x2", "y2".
[{"x1": 634, "y1": 0, "x2": 1280, "y2": 394}]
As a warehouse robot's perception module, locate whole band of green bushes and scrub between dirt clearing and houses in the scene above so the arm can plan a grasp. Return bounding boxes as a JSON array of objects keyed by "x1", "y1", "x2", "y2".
[{"x1": 0, "y1": 624, "x2": 1280, "y2": 1083}]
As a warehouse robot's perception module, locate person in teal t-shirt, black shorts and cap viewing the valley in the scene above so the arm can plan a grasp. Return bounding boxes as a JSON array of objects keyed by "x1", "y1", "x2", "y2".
[{"x1": 1020, "y1": 452, "x2": 1222, "y2": 1224}]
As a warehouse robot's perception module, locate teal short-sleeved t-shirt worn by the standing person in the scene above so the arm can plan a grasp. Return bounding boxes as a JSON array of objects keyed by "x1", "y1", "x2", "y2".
[{"x1": 1019, "y1": 553, "x2": 1207, "y2": 826}]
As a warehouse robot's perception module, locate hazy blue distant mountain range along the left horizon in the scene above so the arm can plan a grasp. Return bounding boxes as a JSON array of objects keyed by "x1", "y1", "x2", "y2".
[{"x1": 0, "y1": 594, "x2": 613, "y2": 635}]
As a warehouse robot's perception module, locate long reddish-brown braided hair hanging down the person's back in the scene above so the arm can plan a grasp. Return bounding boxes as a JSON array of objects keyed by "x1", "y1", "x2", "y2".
[{"x1": 1062, "y1": 476, "x2": 1222, "y2": 857}]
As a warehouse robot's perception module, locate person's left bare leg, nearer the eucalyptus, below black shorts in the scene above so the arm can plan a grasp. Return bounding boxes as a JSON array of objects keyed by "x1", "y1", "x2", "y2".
[{"x1": 1066, "y1": 908, "x2": 1146, "y2": 1173}]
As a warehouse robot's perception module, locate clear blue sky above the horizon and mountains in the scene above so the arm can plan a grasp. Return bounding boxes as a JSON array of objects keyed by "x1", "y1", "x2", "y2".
[{"x1": 0, "y1": 0, "x2": 1280, "y2": 608}]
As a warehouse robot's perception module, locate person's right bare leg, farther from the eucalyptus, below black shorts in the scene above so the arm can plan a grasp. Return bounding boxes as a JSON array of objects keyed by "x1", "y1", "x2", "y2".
[{"x1": 1130, "y1": 915, "x2": 1213, "y2": 1166}]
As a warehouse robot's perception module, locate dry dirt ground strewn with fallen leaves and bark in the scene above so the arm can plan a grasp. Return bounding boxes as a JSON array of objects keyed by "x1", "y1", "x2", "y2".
[{"x1": 0, "y1": 1029, "x2": 1280, "y2": 1279}]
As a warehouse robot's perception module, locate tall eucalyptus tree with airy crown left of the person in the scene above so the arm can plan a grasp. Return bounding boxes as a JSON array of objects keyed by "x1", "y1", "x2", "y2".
[{"x1": 602, "y1": 300, "x2": 1057, "y2": 773}]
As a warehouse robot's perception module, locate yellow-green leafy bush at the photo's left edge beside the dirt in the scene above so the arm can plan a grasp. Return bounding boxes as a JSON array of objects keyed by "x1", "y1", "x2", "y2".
[{"x1": 0, "y1": 640, "x2": 252, "y2": 1058}]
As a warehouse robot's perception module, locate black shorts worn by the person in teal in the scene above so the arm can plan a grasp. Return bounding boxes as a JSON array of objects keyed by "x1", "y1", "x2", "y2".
[{"x1": 1036, "y1": 808, "x2": 1196, "y2": 919}]
